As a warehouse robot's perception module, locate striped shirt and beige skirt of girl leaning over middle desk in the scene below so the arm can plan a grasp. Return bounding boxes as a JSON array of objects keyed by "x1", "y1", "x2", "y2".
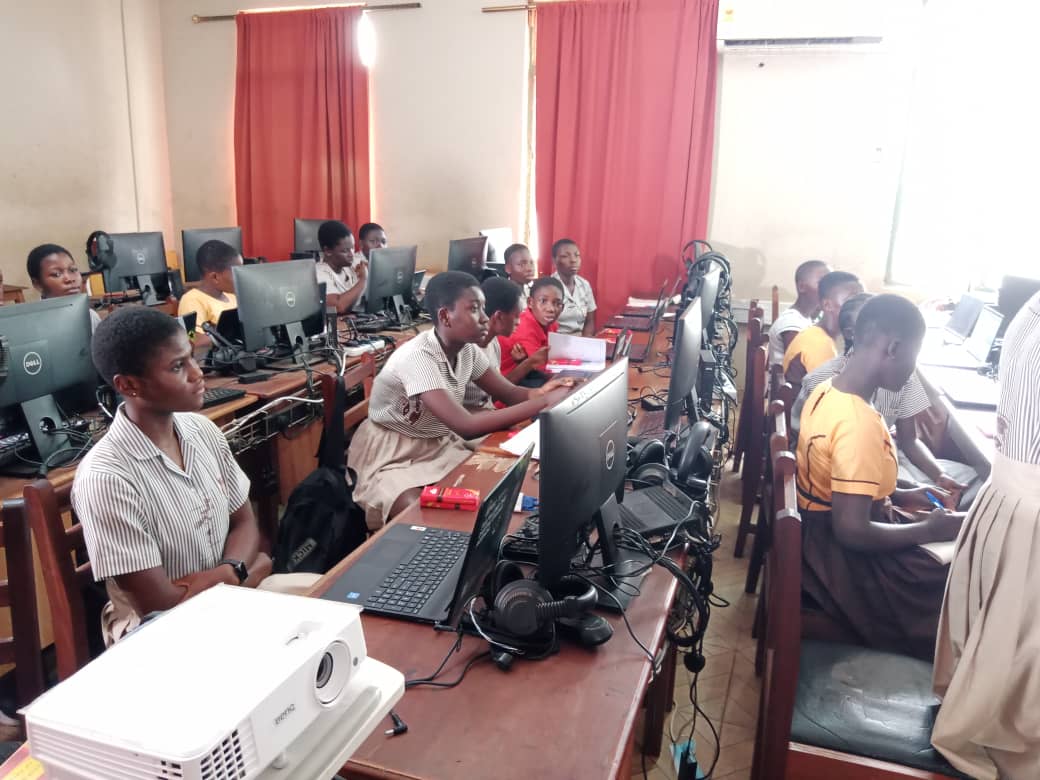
[{"x1": 347, "y1": 329, "x2": 490, "y2": 529}]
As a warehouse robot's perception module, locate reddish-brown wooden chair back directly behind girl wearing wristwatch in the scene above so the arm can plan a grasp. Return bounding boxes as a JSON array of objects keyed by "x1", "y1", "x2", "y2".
[{"x1": 22, "y1": 479, "x2": 94, "y2": 680}]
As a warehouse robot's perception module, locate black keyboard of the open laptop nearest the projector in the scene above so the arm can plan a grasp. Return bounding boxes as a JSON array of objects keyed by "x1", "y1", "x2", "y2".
[{"x1": 365, "y1": 528, "x2": 469, "y2": 615}]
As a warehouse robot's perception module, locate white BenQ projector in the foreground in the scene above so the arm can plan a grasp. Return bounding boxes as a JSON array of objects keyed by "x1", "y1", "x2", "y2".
[{"x1": 23, "y1": 586, "x2": 405, "y2": 780}]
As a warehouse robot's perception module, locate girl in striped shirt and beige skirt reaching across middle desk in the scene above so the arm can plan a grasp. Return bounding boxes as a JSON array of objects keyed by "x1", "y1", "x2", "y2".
[{"x1": 348, "y1": 270, "x2": 569, "y2": 528}]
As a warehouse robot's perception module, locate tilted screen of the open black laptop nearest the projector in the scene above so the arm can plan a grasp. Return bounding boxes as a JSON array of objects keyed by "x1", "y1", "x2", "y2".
[{"x1": 441, "y1": 444, "x2": 535, "y2": 628}]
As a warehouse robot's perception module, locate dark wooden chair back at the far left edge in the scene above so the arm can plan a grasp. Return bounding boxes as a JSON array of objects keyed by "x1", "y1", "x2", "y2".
[{"x1": 0, "y1": 498, "x2": 44, "y2": 708}]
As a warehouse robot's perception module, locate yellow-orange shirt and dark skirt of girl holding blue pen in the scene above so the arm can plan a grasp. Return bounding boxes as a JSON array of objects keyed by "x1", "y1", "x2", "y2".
[{"x1": 798, "y1": 380, "x2": 946, "y2": 657}]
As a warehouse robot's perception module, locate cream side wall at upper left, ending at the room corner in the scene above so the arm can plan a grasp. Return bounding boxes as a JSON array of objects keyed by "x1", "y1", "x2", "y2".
[{"x1": 0, "y1": 0, "x2": 172, "y2": 291}]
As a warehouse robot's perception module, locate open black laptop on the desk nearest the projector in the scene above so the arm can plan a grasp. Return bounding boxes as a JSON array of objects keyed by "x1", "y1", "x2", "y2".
[{"x1": 322, "y1": 445, "x2": 535, "y2": 627}]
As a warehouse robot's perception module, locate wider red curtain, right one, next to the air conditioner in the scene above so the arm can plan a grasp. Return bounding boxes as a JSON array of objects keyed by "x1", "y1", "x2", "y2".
[{"x1": 535, "y1": 0, "x2": 719, "y2": 321}]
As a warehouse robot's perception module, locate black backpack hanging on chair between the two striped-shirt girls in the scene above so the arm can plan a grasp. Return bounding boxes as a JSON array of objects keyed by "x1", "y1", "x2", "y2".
[{"x1": 274, "y1": 376, "x2": 368, "y2": 574}]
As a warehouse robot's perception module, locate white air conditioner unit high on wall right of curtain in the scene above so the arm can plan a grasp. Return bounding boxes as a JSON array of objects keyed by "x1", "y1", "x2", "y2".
[{"x1": 718, "y1": 0, "x2": 891, "y2": 51}]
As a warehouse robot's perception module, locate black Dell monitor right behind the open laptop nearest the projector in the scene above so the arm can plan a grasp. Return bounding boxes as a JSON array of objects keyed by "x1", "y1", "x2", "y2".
[{"x1": 538, "y1": 359, "x2": 644, "y2": 609}]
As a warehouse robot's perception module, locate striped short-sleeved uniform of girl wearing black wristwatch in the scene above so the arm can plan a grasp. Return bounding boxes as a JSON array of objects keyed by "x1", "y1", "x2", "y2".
[{"x1": 72, "y1": 406, "x2": 250, "y2": 644}]
